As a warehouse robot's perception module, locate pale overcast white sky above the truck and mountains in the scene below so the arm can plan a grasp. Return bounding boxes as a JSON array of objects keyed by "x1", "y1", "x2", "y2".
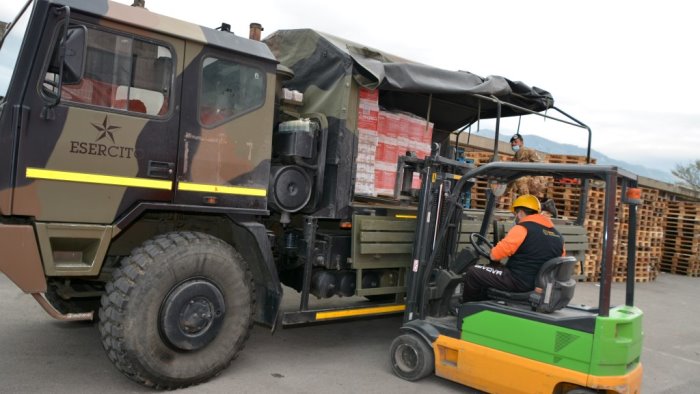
[{"x1": 0, "y1": 0, "x2": 700, "y2": 174}]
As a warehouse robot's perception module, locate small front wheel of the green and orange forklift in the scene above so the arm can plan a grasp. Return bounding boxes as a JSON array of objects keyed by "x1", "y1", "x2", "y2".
[{"x1": 390, "y1": 334, "x2": 435, "y2": 381}]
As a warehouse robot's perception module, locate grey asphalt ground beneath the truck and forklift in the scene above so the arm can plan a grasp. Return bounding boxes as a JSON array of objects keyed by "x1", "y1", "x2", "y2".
[{"x1": 0, "y1": 274, "x2": 700, "y2": 394}]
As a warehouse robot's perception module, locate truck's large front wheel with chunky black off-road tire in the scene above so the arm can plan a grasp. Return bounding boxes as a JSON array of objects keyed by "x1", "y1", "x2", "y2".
[{"x1": 99, "y1": 232, "x2": 255, "y2": 389}]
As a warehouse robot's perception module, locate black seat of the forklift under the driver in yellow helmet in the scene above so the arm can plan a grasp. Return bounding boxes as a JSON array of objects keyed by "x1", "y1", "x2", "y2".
[{"x1": 487, "y1": 256, "x2": 577, "y2": 313}]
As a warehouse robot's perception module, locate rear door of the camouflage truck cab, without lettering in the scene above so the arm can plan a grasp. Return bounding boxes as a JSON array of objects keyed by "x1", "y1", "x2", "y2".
[{"x1": 175, "y1": 40, "x2": 276, "y2": 213}]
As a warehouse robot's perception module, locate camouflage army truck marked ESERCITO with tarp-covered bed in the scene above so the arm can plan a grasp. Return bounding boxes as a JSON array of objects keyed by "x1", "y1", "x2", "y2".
[{"x1": 0, "y1": 0, "x2": 592, "y2": 388}]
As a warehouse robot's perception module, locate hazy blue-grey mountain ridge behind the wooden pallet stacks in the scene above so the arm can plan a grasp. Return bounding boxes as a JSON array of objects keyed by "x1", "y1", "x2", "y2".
[{"x1": 474, "y1": 130, "x2": 678, "y2": 183}]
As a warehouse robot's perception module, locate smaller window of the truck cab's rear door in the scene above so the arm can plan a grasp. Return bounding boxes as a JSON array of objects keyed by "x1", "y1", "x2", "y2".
[{"x1": 199, "y1": 57, "x2": 265, "y2": 127}]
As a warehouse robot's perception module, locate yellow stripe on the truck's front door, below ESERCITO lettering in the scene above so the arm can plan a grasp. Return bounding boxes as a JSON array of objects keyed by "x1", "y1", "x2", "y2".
[{"x1": 26, "y1": 167, "x2": 172, "y2": 190}]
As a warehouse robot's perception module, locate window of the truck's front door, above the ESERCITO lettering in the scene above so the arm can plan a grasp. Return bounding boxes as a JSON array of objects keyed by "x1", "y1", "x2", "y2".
[{"x1": 54, "y1": 27, "x2": 173, "y2": 116}]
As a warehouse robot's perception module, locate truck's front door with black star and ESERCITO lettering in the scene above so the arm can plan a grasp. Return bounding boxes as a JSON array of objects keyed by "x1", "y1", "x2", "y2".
[{"x1": 13, "y1": 14, "x2": 184, "y2": 223}]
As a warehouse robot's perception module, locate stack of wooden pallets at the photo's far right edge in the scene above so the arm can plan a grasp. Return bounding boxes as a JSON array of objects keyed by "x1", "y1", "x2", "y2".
[{"x1": 661, "y1": 201, "x2": 700, "y2": 276}]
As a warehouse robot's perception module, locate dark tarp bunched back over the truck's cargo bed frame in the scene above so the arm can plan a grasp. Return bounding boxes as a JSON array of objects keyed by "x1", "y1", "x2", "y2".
[{"x1": 265, "y1": 29, "x2": 554, "y2": 131}]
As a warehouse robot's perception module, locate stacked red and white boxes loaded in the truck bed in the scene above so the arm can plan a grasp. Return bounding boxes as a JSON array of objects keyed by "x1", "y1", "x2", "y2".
[{"x1": 355, "y1": 89, "x2": 433, "y2": 198}]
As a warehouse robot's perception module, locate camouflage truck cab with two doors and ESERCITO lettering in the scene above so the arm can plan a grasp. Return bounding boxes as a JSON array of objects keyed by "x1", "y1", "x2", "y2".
[{"x1": 0, "y1": 1, "x2": 277, "y2": 304}]
